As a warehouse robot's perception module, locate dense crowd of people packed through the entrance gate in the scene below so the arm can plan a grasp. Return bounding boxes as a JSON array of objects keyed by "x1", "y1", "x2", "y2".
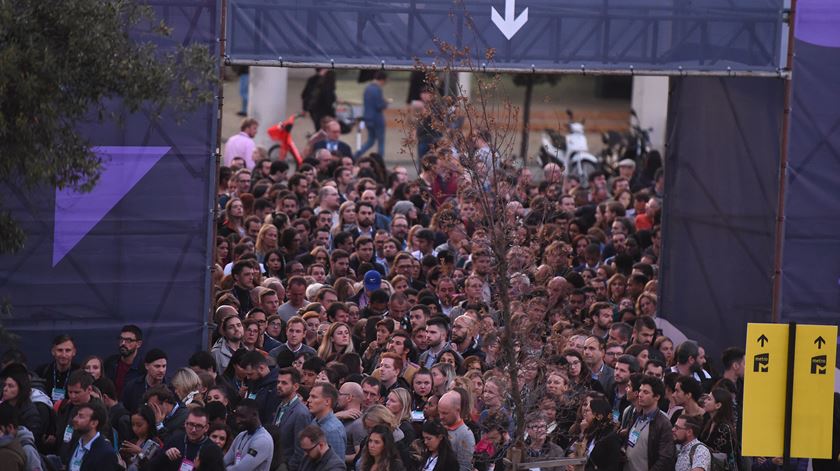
[{"x1": 0, "y1": 94, "x2": 832, "y2": 471}]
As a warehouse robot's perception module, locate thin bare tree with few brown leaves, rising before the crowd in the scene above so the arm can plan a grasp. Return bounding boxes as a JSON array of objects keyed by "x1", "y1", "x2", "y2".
[{"x1": 400, "y1": 38, "x2": 559, "y2": 461}]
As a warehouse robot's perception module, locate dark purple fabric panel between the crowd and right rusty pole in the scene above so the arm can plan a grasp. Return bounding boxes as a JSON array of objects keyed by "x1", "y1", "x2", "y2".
[{"x1": 659, "y1": 77, "x2": 784, "y2": 359}]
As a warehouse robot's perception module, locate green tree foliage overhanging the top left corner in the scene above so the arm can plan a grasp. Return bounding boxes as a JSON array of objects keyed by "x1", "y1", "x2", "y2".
[{"x1": 0, "y1": 0, "x2": 218, "y2": 253}]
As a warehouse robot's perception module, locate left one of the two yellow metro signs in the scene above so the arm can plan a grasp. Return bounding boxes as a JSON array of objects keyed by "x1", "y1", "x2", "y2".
[{"x1": 742, "y1": 324, "x2": 792, "y2": 456}]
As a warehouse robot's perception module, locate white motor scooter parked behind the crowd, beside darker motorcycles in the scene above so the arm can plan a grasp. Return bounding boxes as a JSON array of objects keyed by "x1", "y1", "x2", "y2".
[{"x1": 539, "y1": 110, "x2": 601, "y2": 188}]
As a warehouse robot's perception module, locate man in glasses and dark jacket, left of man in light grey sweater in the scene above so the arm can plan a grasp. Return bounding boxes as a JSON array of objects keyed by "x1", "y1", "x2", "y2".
[{"x1": 149, "y1": 407, "x2": 224, "y2": 471}]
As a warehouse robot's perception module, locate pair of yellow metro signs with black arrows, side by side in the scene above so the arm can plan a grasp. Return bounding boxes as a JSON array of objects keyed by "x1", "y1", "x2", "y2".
[{"x1": 742, "y1": 323, "x2": 840, "y2": 463}]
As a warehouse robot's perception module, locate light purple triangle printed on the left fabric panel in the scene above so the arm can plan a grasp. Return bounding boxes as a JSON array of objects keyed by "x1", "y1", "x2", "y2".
[{"x1": 53, "y1": 146, "x2": 170, "y2": 267}]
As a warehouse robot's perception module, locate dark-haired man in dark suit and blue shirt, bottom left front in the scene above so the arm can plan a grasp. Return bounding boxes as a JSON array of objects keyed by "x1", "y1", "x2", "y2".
[{"x1": 62, "y1": 403, "x2": 120, "y2": 471}]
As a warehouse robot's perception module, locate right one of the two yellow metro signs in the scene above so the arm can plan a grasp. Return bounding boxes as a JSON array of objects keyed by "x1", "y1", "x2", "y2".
[{"x1": 790, "y1": 325, "x2": 840, "y2": 458}]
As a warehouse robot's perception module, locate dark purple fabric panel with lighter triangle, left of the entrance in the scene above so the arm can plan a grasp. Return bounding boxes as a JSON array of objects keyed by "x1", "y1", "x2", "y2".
[{"x1": 0, "y1": 0, "x2": 219, "y2": 365}]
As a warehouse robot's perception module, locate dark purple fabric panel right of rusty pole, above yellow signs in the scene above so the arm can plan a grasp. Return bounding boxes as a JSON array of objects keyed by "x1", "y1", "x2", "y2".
[{"x1": 781, "y1": 37, "x2": 840, "y2": 332}]
